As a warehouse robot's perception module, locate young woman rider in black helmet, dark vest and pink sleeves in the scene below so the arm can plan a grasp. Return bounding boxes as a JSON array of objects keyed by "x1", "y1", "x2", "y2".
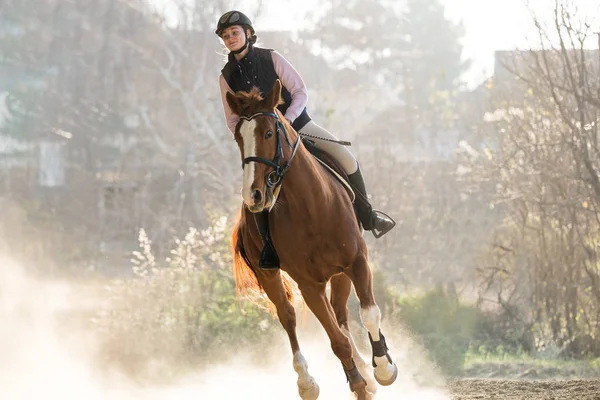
[{"x1": 215, "y1": 10, "x2": 395, "y2": 268}]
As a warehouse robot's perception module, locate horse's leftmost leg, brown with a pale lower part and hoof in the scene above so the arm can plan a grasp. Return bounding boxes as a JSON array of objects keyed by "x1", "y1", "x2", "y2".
[{"x1": 256, "y1": 270, "x2": 319, "y2": 400}]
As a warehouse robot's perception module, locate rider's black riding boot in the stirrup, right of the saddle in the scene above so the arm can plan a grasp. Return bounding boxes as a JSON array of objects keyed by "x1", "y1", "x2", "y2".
[{"x1": 348, "y1": 166, "x2": 396, "y2": 238}]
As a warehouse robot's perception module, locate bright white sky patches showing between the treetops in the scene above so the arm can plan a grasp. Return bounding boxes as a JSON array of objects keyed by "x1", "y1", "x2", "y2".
[{"x1": 148, "y1": 0, "x2": 600, "y2": 86}]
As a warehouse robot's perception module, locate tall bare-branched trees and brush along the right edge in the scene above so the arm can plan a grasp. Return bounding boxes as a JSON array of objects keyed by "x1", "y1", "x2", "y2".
[{"x1": 472, "y1": 0, "x2": 600, "y2": 355}]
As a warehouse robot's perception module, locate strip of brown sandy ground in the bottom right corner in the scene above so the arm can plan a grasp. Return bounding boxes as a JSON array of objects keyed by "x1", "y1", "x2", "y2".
[{"x1": 448, "y1": 379, "x2": 600, "y2": 400}]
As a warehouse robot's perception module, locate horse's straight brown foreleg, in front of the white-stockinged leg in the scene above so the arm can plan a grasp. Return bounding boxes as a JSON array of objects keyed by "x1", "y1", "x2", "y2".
[{"x1": 299, "y1": 282, "x2": 371, "y2": 400}]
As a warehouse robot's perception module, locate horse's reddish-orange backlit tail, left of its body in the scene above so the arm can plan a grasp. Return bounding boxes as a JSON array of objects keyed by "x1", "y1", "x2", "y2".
[{"x1": 231, "y1": 213, "x2": 297, "y2": 311}]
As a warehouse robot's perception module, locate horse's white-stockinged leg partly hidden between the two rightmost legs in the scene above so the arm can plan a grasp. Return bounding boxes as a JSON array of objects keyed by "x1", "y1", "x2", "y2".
[{"x1": 331, "y1": 274, "x2": 377, "y2": 393}]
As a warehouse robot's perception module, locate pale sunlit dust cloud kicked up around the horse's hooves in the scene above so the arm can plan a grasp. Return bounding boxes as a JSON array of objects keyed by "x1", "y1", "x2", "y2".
[{"x1": 0, "y1": 255, "x2": 449, "y2": 400}]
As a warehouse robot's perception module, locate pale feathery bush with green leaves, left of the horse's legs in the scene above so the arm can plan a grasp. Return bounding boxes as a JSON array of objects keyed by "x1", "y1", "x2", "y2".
[{"x1": 95, "y1": 219, "x2": 279, "y2": 379}]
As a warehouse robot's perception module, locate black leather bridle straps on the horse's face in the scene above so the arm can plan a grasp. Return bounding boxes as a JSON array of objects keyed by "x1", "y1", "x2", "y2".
[{"x1": 240, "y1": 112, "x2": 300, "y2": 190}]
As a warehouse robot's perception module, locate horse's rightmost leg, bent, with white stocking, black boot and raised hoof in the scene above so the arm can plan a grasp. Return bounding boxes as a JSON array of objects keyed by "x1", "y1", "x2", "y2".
[{"x1": 346, "y1": 256, "x2": 398, "y2": 386}]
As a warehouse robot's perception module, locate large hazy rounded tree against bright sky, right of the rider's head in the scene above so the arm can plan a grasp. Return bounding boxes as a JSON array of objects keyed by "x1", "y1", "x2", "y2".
[{"x1": 307, "y1": 0, "x2": 467, "y2": 142}]
